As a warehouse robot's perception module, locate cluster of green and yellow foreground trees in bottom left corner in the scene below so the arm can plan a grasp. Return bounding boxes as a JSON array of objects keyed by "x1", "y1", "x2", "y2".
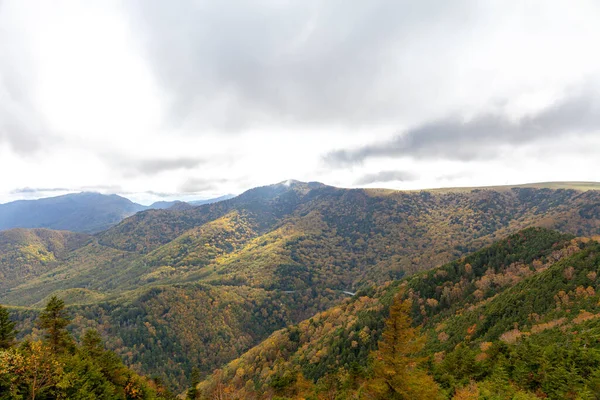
[{"x1": 0, "y1": 297, "x2": 175, "y2": 400}]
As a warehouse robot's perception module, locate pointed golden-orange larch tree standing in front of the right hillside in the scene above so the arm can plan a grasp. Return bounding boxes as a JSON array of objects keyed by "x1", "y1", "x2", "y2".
[{"x1": 366, "y1": 294, "x2": 439, "y2": 400}]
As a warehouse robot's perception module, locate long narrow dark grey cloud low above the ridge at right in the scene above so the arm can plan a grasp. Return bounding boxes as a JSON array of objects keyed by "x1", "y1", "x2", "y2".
[{"x1": 324, "y1": 91, "x2": 600, "y2": 167}]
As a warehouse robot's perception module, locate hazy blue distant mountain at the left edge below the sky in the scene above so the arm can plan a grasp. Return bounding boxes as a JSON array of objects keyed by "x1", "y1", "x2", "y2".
[{"x1": 0, "y1": 192, "x2": 146, "y2": 233}]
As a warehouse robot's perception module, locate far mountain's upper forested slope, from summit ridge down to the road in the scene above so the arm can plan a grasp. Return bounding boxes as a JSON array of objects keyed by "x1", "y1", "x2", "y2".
[{"x1": 9, "y1": 183, "x2": 600, "y2": 305}]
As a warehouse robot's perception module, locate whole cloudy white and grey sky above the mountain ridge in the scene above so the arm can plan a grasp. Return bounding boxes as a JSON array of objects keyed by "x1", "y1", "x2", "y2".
[{"x1": 0, "y1": 0, "x2": 600, "y2": 204}]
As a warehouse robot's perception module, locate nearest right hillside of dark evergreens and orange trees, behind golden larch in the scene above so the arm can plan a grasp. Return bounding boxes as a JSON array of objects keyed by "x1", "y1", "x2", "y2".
[{"x1": 199, "y1": 229, "x2": 600, "y2": 399}]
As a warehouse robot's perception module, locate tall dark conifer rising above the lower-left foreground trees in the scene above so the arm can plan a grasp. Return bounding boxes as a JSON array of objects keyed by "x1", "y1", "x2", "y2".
[{"x1": 39, "y1": 296, "x2": 71, "y2": 353}]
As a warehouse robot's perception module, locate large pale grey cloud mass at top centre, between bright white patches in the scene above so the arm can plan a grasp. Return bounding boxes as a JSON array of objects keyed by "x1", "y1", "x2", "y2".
[{"x1": 128, "y1": 0, "x2": 471, "y2": 131}]
